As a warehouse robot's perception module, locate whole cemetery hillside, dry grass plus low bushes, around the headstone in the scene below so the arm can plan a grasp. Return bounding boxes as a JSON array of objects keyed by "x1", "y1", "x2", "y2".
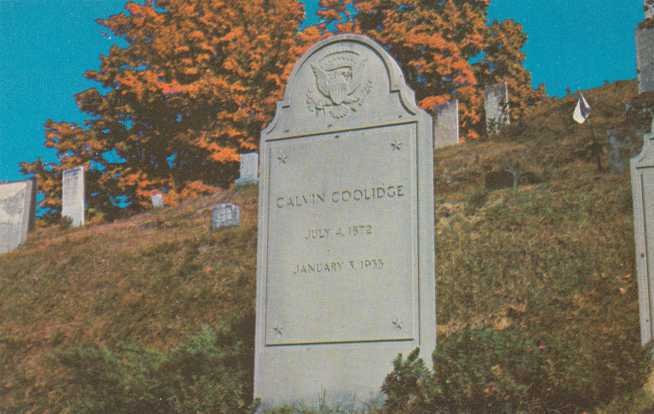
[{"x1": 0, "y1": 82, "x2": 654, "y2": 414}]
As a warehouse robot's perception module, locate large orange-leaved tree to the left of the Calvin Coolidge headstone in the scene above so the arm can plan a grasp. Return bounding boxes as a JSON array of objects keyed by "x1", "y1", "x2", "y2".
[{"x1": 22, "y1": 0, "x2": 320, "y2": 222}]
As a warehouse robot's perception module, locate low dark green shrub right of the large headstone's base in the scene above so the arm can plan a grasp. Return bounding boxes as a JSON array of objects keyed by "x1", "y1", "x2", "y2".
[{"x1": 382, "y1": 328, "x2": 649, "y2": 414}]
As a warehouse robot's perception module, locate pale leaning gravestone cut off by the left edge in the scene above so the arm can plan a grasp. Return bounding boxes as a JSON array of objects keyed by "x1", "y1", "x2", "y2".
[{"x1": 0, "y1": 180, "x2": 36, "y2": 254}]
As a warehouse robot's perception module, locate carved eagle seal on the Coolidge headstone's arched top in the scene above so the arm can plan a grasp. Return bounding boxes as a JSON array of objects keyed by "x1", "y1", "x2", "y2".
[{"x1": 307, "y1": 50, "x2": 372, "y2": 119}]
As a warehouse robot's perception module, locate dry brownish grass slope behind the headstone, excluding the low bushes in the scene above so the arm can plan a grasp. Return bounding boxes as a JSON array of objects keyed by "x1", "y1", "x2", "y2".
[{"x1": 0, "y1": 82, "x2": 642, "y2": 412}]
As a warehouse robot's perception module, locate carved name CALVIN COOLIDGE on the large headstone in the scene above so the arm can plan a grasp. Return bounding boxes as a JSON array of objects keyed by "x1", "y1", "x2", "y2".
[{"x1": 275, "y1": 184, "x2": 406, "y2": 208}]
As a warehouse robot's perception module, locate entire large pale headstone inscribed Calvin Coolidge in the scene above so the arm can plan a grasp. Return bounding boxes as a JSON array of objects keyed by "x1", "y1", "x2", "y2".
[{"x1": 254, "y1": 34, "x2": 436, "y2": 407}]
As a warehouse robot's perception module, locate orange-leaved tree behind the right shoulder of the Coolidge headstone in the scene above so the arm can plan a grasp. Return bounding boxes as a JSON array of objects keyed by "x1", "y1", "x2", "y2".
[{"x1": 318, "y1": 0, "x2": 540, "y2": 140}]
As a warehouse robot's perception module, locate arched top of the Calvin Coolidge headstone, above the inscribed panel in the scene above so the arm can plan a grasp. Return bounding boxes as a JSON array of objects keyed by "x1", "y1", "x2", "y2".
[{"x1": 262, "y1": 34, "x2": 429, "y2": 140}]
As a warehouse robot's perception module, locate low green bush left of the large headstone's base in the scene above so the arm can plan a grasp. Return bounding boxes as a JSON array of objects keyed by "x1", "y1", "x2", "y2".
[{"x1": 57, "y1": 318, "x2": 254, "y2": 414}]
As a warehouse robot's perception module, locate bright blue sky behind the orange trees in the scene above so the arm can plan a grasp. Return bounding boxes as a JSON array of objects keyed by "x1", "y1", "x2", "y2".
[{"x1": 0, "y1": 0, "x2": 643, "y2": 181}]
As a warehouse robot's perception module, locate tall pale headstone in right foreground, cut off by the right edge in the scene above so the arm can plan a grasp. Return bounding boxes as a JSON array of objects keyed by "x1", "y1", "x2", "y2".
[{"x1": 631, "y1": 121, "x2": 654, "y2": 345}]
